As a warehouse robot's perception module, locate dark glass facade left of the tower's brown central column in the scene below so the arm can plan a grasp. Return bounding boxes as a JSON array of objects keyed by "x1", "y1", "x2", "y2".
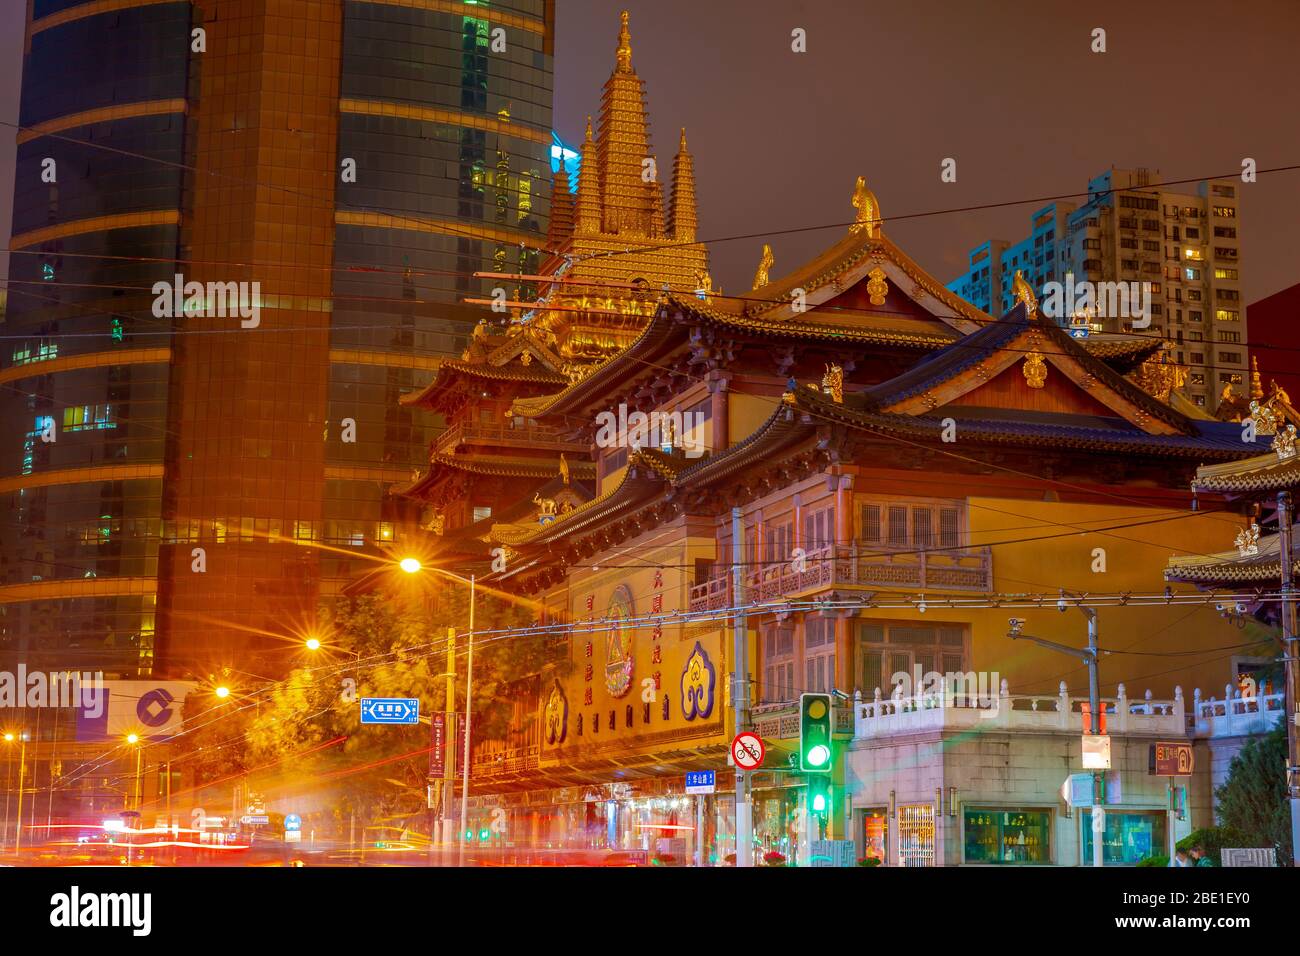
[{"x1": 0, "y1": 0, "x2": 190, "y2": 676}]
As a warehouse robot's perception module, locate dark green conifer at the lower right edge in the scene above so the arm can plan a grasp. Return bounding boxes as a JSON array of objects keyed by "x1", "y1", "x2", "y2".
[{"x1": 1214, "y1": 723, "x2": 1291, "y2": 866}]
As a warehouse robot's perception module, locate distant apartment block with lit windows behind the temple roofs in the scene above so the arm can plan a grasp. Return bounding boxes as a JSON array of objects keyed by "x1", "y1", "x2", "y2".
[{"x1": 948, "y1": 169, "x2": 1249, "y2": 412}]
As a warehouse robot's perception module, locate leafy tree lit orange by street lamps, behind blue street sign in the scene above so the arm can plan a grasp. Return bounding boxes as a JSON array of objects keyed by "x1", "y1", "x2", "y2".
[{"x1": 182, "y1": 587, "x2": 547, "y2": 829}]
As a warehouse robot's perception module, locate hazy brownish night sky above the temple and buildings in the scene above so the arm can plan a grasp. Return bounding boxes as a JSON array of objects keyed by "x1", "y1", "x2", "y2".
[{"x1": 0, "y1": 0, "x2": 1300, "y2": 314}]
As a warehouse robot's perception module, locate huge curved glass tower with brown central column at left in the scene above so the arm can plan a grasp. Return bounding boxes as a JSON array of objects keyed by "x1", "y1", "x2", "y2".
[{"x1": 0, "y1": 0, "x2": 554, "y2": 678}]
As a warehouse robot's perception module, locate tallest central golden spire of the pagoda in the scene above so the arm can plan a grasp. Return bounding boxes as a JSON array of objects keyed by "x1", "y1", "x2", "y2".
[{"x1": 598, "y1": 10, "x2": 663, "y2": 238}]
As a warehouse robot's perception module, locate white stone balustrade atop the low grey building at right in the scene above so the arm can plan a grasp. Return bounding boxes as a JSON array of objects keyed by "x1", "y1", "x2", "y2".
[{"x1": 853, "y1": 672, "x2": 1286, "y2": 740}]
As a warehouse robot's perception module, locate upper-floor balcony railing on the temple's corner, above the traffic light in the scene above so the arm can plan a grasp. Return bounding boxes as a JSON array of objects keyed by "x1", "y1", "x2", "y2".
[{"x1": 690, "y1": 544, "x2": 993, "y2": 611}]
